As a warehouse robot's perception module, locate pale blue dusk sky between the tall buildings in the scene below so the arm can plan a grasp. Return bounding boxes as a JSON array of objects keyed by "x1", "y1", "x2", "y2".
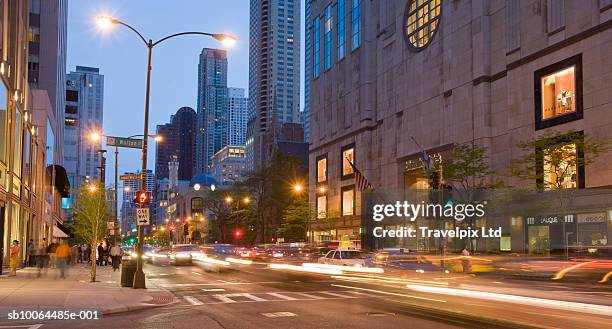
[{"x1": 67, "y1": 0, "x2": 249, "y2": 186}]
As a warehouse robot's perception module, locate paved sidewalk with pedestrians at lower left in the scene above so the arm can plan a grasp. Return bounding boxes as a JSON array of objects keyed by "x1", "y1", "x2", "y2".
[{"x1": 0, "y1": 264, "x2": 174, "y2": 315}]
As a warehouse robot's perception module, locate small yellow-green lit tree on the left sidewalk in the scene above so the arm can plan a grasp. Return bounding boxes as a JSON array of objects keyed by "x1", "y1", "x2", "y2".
[{"x1": 74, "y1": 182, "x2": 112, "y2": 282}]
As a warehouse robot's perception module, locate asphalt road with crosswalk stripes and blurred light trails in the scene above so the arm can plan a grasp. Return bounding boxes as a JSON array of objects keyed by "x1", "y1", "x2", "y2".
[{"x1": 4, "y1": 258, "x2": 612, "y2": 329}]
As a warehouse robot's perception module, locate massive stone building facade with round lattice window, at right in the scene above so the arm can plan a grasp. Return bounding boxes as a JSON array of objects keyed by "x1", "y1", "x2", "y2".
[{"x1": 306, "y1": 0, "x2": 612, "y2": 246}]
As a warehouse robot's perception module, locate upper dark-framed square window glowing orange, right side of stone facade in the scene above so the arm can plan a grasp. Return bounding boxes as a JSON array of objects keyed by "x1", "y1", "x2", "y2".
[{"x1": 534, "y1": 55, "x2": 582, "y2": 129}]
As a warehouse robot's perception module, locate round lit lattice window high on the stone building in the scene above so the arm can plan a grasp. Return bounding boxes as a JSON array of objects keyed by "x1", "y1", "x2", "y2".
[{"x1": 404, "y1": 0, "x2": 442, "y2": 51}]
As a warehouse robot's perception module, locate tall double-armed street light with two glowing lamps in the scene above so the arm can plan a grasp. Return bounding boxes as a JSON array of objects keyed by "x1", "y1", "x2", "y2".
[{"x1": 98, "y1": 16, "x2": 236, "y2": 289}]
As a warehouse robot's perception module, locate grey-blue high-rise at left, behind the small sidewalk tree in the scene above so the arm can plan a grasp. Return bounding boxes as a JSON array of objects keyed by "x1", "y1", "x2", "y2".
[{"x1": 64, "y1": 66, "x2": 104, "y2": 201}]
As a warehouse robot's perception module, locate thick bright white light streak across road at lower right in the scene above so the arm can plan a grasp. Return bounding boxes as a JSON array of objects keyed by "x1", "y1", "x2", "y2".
[{"x1": 406, "y1": 284, "x2": 612, "y2": 316}]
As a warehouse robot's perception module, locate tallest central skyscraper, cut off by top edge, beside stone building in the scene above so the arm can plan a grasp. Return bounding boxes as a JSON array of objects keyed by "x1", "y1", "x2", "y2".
[{"x1": 246, "y1": 0, "x2": 300, "y2": 169}]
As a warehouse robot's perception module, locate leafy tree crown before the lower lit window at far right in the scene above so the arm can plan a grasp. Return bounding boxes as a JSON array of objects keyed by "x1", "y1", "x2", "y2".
[{"x1": 510, "y1": 130, "x2": 612, "y2": 189}]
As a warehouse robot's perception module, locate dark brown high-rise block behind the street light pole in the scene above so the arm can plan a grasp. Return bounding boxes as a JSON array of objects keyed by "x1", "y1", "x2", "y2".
[{"x1": 155, "y1": 106, "x2": 196, "y2": 180}]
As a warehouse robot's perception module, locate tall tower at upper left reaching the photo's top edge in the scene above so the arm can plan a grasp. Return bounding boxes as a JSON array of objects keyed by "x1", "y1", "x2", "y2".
[{"x1": 28, "y1": 0, "x2": 68, "y2": 164}]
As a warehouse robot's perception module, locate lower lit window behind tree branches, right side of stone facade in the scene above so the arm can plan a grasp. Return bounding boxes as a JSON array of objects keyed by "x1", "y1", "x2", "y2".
[{"x1": 543, "y1": 144, "x2": 578, "y2": 189}]
